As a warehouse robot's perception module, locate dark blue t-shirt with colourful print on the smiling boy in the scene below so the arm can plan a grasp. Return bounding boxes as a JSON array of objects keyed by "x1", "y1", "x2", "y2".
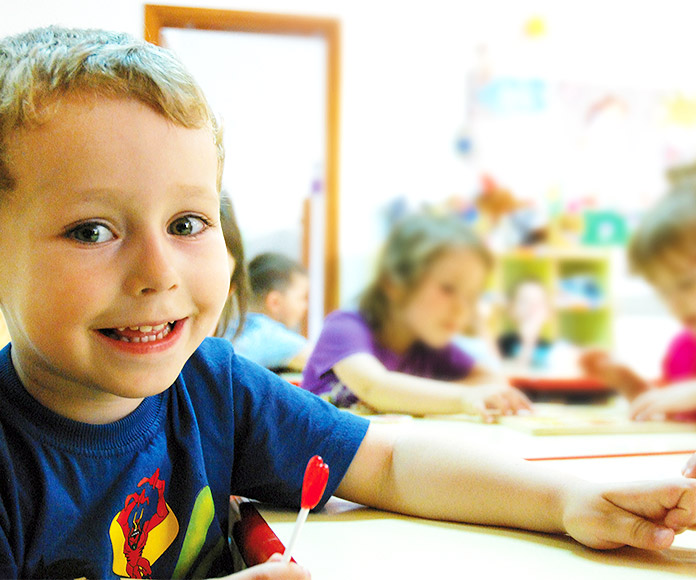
[{"x1": 0, "y1": 338, "x2": 368, "y2": 578}]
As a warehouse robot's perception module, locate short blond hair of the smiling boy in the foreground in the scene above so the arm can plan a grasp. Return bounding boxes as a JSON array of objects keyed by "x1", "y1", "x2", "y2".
[{"x1": 0, "y1": 27, "x2": 224, "y2": 194}]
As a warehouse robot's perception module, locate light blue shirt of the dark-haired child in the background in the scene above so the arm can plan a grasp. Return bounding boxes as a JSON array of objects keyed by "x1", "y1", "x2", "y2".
[{"x1": 225, "y1": 312, "x2": 307, "y2": 369}]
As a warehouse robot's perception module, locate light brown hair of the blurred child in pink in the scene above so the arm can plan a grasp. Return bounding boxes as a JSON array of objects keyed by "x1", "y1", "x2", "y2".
[{"x1": 628, "y1": 181, "x2": 696, "y2": 279}]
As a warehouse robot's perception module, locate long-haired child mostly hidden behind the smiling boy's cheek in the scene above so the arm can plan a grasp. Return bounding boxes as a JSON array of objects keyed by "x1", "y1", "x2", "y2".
[{"x1": 215, "y1": 191, "x2": 249, "y2": 340}]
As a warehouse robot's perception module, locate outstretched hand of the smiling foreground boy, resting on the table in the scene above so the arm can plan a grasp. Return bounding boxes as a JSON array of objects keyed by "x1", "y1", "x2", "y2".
[{"x1": 563, "y1": 479, "x2": 696, "y2": 550}]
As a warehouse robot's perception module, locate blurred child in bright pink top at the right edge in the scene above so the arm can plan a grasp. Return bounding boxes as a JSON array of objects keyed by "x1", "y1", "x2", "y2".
[{"x1": 580, "y1": 184, "x2": 696, "y2": 420}]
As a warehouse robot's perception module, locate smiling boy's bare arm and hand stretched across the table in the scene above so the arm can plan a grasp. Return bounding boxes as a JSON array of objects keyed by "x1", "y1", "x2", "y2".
[{"x1": 336, "y1": 424, "x2": 696, "y2": 550}]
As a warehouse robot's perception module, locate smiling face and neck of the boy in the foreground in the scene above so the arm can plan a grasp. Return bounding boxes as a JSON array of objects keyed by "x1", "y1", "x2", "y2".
[{"x1": 0, "y1": 98, "x2": 230, "y2": 423}]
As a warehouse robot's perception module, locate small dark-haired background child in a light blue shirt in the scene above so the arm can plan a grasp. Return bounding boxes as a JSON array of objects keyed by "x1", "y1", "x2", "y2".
[{"x1": 233, "y1": 252, "x2": 311, "y2": 371}]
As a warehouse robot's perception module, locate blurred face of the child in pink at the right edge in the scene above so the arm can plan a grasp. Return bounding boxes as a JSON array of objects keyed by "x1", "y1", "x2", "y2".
[{"x1": 649, "y1": 249, "x2": 696, "y2": 333}]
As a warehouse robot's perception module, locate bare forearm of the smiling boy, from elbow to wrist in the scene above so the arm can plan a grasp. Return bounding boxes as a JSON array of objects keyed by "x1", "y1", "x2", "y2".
[{"x1": 346, "y1": 427, "x2": 580, "y2": 533}]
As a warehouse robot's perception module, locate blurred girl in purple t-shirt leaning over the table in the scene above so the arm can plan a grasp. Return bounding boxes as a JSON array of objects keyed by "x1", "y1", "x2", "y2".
[{"x1": 302, "y1": 214, "x2": 531, "y2": 420}]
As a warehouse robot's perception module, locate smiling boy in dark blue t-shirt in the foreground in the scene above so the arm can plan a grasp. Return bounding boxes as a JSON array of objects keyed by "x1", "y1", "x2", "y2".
[{"x1": 0, "y1": 24, "x2": 696, "y2": 580}]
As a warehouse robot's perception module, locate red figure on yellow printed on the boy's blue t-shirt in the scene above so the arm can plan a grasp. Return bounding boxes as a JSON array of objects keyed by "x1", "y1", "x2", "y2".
[{"x1": 109, "y1": 469, "x2": 179, "y2": 578}]
